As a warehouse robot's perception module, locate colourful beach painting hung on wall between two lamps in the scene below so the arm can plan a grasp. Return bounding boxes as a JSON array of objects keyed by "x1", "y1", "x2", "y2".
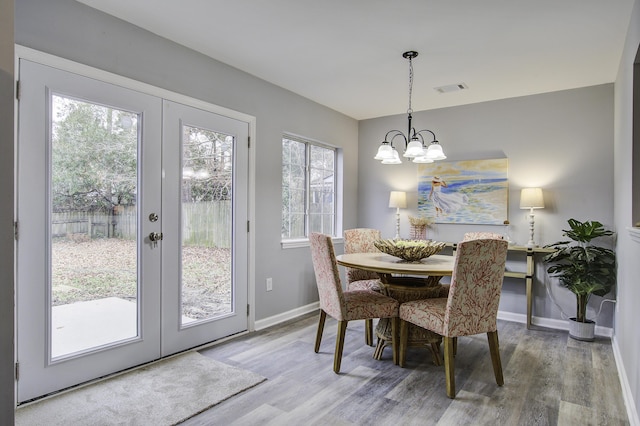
[{"x1": 418, "y1": 158, "x2": 509, "y2": 225}]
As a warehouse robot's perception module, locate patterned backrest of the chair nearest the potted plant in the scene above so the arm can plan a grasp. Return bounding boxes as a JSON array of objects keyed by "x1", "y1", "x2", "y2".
[{"x1": 444, "y1": 239, "x2": 509, "y2": 337}]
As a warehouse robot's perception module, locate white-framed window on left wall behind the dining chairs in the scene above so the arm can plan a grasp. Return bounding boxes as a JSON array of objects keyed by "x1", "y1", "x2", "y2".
[{"x1": 282, "y1": 135, "x2": 336, "y2": 240}]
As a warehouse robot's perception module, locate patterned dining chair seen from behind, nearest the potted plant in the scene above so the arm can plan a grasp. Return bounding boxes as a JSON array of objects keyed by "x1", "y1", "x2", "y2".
[{"x1": 397, "y1": 239, "x2": 509, "y2": 398}]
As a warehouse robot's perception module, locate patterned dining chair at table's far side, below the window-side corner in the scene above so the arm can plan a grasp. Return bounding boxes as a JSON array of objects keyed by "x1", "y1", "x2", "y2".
[{"x1": 344, "y1": 228, "x2": 382, "y2": 346}]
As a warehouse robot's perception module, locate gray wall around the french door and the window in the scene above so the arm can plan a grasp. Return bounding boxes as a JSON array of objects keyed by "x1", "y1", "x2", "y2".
[{"x1": 15, "y1": 0, "x2": 358, "y2": 320}]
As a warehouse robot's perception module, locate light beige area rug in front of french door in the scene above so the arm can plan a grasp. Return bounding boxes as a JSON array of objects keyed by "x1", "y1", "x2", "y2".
[{"x1": 16, "y1": 352, "x2": 266, "y2": 426}]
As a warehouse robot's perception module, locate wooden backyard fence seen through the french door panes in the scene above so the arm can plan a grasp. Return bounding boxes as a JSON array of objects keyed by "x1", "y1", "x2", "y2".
[{"x1": 51, "y1": 201, "x2": 233, "y2": 248}]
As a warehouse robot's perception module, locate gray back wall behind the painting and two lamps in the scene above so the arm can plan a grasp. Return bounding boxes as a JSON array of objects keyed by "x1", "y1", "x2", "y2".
[{"x1": 358, "y1": 84, "x2": 614, "y2": 327}]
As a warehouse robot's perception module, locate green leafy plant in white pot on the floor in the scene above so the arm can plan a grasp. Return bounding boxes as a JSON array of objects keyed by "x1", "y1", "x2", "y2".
[{"x1": 543, "y1": 219, "x2": 616, "y2": 341}]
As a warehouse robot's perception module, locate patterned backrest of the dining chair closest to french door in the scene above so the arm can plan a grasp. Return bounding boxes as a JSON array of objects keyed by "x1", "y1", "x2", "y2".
[{"x1": 309, "y1": 232, "x2": 346, "y2": 320}]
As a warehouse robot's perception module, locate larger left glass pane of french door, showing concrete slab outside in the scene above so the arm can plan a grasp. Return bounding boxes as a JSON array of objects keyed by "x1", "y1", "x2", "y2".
[{"x1": 49, "y1": 94, "x2": 139, "y2": 360}]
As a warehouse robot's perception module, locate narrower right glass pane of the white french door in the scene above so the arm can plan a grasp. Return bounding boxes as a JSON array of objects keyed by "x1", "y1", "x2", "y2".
[{"x1": 181, "y1": 125, "x2": 234, "y2": 324}]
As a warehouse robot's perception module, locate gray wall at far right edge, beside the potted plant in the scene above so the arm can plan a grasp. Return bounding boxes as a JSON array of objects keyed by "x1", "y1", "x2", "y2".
[{"x1": 614, "y1": 0, "x2": 640, "y2": 420}]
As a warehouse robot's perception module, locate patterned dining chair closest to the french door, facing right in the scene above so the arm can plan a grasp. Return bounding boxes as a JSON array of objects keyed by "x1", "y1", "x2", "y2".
[{"x1": 309, "y1": 232, "x2": 400, "y2": 373}]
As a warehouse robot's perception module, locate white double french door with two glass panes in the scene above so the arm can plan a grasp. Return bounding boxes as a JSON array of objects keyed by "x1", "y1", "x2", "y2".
[{"x1": 16, "y1": 59, "x2": 248, "y2": 402}]
